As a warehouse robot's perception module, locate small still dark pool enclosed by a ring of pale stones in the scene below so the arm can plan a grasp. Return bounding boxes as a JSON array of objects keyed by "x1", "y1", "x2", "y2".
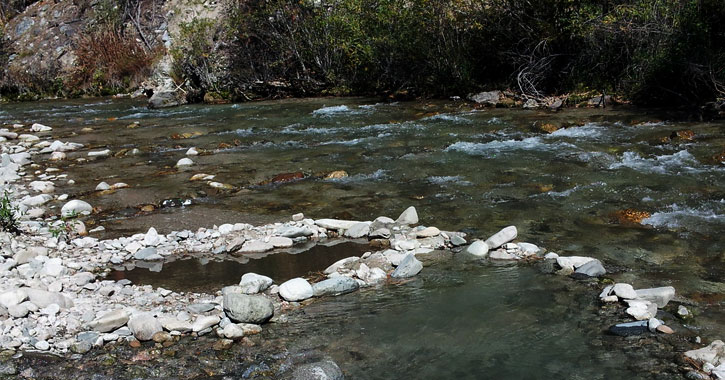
[{"x1": 108, "y1": 242, "x2": 371, "y2": 293}]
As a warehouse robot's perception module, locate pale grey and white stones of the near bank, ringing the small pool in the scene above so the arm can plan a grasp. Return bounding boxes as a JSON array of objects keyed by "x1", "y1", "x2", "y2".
[{"x1": 0, "y1": 124, "x2": 725, "y2": 378}]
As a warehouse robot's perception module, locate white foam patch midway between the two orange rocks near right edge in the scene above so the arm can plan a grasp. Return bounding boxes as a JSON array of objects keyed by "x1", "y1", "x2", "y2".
[{"x1": 609, "y1": 150, "x2": 703, "y2": 174}]
